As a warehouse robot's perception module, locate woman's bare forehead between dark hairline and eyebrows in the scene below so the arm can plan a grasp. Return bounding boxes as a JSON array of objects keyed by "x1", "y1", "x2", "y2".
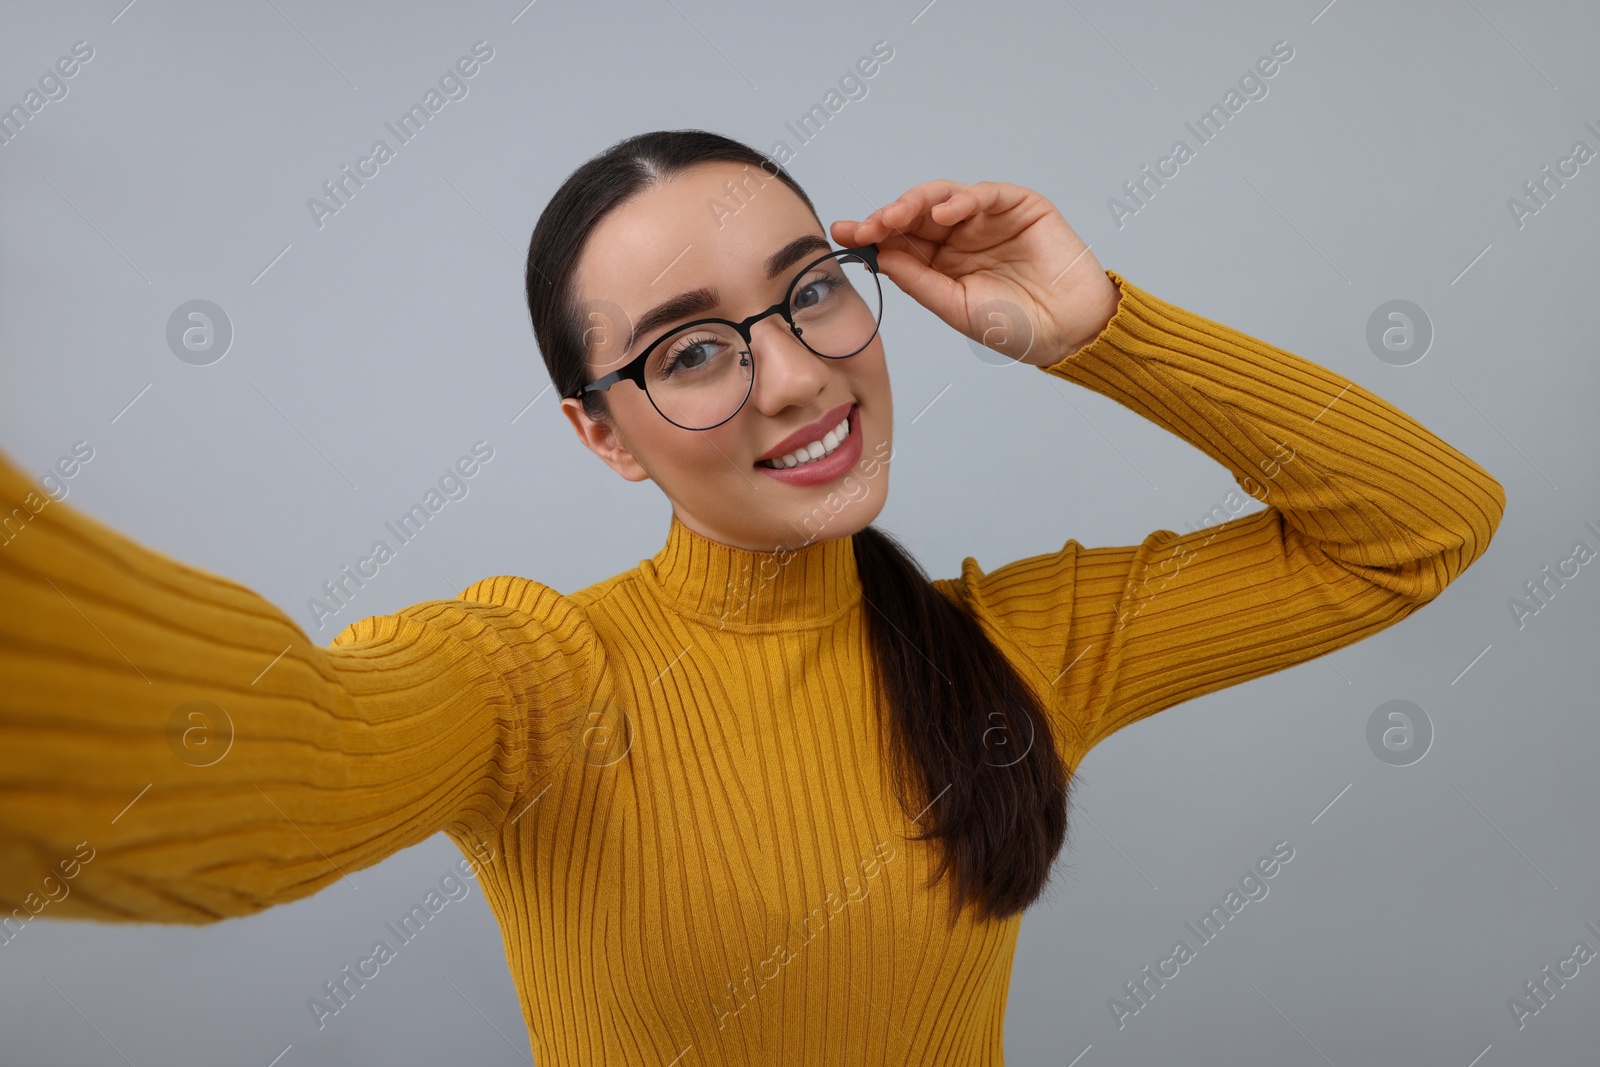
[{"x1": 573, "y1": 162, "x2": 822, "y2": 317}]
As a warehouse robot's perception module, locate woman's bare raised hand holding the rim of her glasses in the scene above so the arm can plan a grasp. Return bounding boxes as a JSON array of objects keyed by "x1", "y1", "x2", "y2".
[{"x1": 832, "y1": 179, "x2": 1120, "y2": 366}]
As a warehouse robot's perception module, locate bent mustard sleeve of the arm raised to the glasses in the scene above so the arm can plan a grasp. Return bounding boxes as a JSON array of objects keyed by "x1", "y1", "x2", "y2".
[{"x1": 936, "y1": 270, "x2": 1506, "y2": 766}]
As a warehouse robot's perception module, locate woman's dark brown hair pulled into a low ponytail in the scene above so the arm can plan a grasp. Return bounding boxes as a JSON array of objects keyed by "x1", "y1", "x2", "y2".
[{"x1": 526, "y1": 130, "x2": 1069, "y2": 921}]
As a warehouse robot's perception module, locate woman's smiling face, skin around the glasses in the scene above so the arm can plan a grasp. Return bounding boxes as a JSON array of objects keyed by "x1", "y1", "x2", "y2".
[{"x1": 562, "y1": 163, "x2": 894, "y2": 550}]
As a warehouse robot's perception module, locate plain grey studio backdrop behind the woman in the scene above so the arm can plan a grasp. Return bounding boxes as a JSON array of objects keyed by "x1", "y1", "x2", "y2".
[{"x1": 0, "y1": 0, "x2": 1600, "y2": 1067}]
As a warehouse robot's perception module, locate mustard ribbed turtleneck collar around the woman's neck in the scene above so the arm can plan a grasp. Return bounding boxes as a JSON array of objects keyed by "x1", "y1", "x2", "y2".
[{"x1": 640, "y1": 514, "x2": 861, "y2": 632}]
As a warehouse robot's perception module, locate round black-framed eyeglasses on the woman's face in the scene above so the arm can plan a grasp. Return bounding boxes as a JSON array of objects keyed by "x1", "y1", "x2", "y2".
[{"x1": 568, "y1": 245, "x2": 883, "y2": 430}]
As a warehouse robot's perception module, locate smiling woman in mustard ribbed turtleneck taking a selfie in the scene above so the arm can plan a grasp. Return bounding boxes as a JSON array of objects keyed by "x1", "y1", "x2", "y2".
[{"x1": 0, "y1": 131, "x2": 1504, "y2": 1067}]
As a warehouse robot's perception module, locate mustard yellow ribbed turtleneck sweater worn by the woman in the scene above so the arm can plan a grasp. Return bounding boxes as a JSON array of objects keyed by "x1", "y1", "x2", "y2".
[{"x1": 0, "y1": 270, "x2": 1506, "y2": 1067}]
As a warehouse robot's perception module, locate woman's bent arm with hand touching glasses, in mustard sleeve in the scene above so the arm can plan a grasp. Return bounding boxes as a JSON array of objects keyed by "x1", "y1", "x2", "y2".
[{"x1": 834, "y1": 179, "x2": 1506, "y2": 765}]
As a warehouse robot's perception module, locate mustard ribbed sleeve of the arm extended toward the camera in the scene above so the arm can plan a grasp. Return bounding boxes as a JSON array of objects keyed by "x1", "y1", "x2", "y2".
[{"x1": 0, "y1": 454, "x2": 597, "y2": 941}]
